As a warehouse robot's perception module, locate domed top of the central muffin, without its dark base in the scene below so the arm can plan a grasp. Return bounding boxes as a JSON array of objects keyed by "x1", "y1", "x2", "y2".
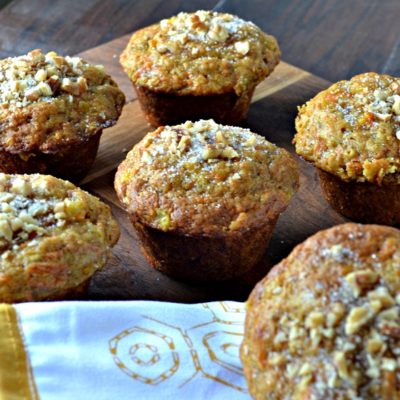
[{"x1": 115, "y1": 120, "x2": 299, "y2": 235}]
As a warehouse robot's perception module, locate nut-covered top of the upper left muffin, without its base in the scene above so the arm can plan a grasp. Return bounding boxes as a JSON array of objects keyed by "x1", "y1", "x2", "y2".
[{"x1": 0, "y1": 50, "x2": 125, "y2": 154}]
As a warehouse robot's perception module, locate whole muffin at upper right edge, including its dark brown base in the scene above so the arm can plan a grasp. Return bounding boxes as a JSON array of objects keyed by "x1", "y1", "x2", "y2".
[{"x1": 294, "y1": 72, "x2": 400, "y2": 225}]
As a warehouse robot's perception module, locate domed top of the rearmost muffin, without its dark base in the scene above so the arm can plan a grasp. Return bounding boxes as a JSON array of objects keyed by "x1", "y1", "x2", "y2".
[{"x1": 121, "y1": 11, "x2": 280, "y2": 95}]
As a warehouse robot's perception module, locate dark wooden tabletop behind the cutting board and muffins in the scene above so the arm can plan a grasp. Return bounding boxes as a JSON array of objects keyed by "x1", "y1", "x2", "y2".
[{"x1": 0, "y1": 0, "x2": 400, "y2": 81}]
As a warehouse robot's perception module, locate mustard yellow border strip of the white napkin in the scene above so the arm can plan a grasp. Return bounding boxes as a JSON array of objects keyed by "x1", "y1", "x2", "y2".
[{"x1": 0, "y1": 304, "x2": 39, "y2": 400}]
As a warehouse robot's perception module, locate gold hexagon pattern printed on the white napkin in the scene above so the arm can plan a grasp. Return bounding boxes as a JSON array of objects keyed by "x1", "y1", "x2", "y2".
[{"x1": 109, "y1": 302, "x2": 247, "y2": 393}]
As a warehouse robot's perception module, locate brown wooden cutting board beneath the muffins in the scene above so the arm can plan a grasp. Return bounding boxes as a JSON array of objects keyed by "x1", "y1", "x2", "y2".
[{"x1": 79, "y1": 35, "x2": 345, "y2": 302}]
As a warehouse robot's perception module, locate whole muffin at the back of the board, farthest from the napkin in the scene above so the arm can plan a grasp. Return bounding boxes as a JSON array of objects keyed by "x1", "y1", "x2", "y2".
[{"x1": 121, "y1": 11, "x2": 280, "y2": 126}]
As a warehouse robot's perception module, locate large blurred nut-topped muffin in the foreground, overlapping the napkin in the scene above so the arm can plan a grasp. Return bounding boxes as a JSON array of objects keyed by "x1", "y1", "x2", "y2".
[{"x1": 241, "y1": 223, "x2": 400, "y2": 400}]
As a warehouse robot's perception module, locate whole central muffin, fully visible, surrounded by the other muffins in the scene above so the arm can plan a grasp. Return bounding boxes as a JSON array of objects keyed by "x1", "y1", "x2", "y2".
[{"x1": 115, "y1": 120, "x2": 299, "y2": 280}]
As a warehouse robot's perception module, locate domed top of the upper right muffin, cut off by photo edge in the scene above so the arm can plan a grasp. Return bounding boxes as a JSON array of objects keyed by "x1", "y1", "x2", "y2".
[{"x1": 294, "y1": 72, "x2": 400, "y2": 184}]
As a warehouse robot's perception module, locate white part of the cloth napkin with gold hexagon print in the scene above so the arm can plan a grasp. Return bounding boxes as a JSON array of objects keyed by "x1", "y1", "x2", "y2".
[{"x1": 16, "y1": 301, "x2": 250, "y2": 400}]
